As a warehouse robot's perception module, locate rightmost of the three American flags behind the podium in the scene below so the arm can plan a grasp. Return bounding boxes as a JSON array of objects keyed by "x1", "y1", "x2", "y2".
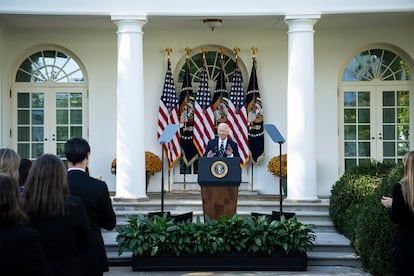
[{"x1": 227, "y1": 62, "x2": 249, "y2": 167}]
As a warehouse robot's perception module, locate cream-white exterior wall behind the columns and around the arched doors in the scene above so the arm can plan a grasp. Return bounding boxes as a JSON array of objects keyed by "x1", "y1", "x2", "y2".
[{"x1": 0, "y1": 12, "x2": 414, "y2": 196}]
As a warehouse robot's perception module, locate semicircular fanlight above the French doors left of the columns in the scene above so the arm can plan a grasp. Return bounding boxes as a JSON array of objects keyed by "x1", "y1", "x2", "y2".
[{"x1": 15, "y1": 49, "x2": 85, "y2": 83}]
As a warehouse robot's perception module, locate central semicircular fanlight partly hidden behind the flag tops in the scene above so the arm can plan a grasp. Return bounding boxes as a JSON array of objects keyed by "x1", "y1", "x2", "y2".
[{"x1": 177, "y1": 45, "x2": 246, "y2": 86}]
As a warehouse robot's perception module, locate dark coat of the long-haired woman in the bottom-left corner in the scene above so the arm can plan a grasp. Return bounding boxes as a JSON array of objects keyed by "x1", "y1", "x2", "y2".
[{"x1": 0, "y1": 225, "x2": 52, "y2": 276}]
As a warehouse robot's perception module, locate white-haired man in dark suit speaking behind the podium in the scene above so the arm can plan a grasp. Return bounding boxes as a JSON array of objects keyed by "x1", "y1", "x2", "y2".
[{"x1": 204, "y1": 123, "x2": 240, "y2": 157}]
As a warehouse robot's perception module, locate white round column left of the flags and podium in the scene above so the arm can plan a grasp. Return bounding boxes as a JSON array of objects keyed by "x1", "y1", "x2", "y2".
[{"x1": 112, "y1": 16, "x2": 147, "y2": 199}]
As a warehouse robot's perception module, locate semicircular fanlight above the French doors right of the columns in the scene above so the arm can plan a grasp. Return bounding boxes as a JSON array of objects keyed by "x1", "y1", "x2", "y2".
[{"x1": 342, "y1": 48, "x2": 412, "y2": 82}]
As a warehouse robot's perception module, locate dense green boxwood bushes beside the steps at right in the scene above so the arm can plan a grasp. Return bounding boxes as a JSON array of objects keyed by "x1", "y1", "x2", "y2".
[{"x1": 329, "y1": 163, "x2": 402, "y2": 275}]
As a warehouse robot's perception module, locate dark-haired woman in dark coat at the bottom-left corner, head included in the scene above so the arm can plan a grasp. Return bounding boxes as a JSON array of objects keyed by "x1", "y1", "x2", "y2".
[{"x1": 0, "y1": 173, "x2": 51, "y2": 276}]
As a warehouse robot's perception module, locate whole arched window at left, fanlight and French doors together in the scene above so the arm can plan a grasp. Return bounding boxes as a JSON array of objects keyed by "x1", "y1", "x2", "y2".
[{"x1": 11, "y1": 46, "x2": 88, "y2": 160}]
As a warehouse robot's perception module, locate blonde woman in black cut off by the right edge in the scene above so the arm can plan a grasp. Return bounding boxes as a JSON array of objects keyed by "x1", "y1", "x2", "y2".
[{"x1": 381, "y1": 151, "x2": 414, "y2": 276}]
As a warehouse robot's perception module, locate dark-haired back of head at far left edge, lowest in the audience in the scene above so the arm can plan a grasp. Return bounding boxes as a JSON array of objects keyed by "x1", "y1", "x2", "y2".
[{"x1": 0, "y1": 173, "x2": 26, "y2": 225}]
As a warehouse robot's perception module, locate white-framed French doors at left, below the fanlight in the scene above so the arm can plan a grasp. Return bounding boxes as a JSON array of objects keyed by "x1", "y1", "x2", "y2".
[{"x1": 10, "y1": 86, "x2": 87, "y2": 160}]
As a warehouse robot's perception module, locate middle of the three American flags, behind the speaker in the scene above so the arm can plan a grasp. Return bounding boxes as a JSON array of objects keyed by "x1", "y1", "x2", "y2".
[{"x1": 193, "y1": 59, "x2": 215, "y2": 155}]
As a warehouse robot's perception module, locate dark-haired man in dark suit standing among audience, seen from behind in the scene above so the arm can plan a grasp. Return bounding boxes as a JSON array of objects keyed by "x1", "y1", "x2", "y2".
[{"x1": 64, "y1": 138, "x2": 116, "y2": 276}]
